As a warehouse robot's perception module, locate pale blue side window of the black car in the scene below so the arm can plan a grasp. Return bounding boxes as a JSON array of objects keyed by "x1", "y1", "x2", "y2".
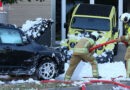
[{"x1": 0, "y1": 28, "x2": 22, "y2": 44}]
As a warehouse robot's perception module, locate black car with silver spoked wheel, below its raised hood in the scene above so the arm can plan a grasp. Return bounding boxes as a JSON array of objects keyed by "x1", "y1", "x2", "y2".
[{"x1": 0, "y1": 24, "x2": 64, "y2": 79}]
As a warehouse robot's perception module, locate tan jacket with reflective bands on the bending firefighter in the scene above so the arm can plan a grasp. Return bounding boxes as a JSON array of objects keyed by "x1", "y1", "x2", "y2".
[{"x1": 73, "y1": 38, "x2": 95, "y2": 54}]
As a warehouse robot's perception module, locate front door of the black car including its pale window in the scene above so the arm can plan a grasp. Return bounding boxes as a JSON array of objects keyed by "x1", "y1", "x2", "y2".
[{"x1": 0, "y1": 28, "x2": 34, "y2": 68}]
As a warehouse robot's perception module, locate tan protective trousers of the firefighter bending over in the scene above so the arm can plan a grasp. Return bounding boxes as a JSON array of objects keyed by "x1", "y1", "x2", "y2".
[{"x1": 64, "y1": 54, "x2": 99, "y2": 81}]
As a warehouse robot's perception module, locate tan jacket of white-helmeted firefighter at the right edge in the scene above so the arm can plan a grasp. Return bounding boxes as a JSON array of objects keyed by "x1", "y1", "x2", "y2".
[{"x1": 120, "y1": 33, "x2": 130, "y2": 60}]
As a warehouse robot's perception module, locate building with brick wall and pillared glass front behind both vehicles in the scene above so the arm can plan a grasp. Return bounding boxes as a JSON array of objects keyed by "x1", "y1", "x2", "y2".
[{"x1": 0, "y1": 0, "x2": 130, "y2": 44}]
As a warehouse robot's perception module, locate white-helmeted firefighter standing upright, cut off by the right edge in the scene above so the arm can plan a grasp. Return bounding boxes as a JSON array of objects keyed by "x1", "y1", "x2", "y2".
[{"x1": 118, "y1": 13, "x2": 130, "y2": 78}]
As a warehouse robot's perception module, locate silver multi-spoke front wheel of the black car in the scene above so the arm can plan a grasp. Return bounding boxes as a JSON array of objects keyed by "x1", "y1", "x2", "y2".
[{"x1": 37, "y1": 58, "x2": 57, "y2": 80}]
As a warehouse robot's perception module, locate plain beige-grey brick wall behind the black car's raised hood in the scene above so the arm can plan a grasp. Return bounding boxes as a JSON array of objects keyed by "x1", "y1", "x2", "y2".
[{"x1": 8, "y1": 0, "x2": 51, "y2": 26}]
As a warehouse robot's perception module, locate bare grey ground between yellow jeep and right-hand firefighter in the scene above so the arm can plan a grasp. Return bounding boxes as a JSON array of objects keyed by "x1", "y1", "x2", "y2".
[{"x1": 113, "y1": 43, "x2": 126, "y2": 61}]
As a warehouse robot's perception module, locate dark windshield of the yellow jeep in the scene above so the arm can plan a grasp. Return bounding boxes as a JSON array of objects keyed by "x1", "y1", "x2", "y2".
[{"x1": 71, "y1": 17, "x2": 110, "y2": 31}]
